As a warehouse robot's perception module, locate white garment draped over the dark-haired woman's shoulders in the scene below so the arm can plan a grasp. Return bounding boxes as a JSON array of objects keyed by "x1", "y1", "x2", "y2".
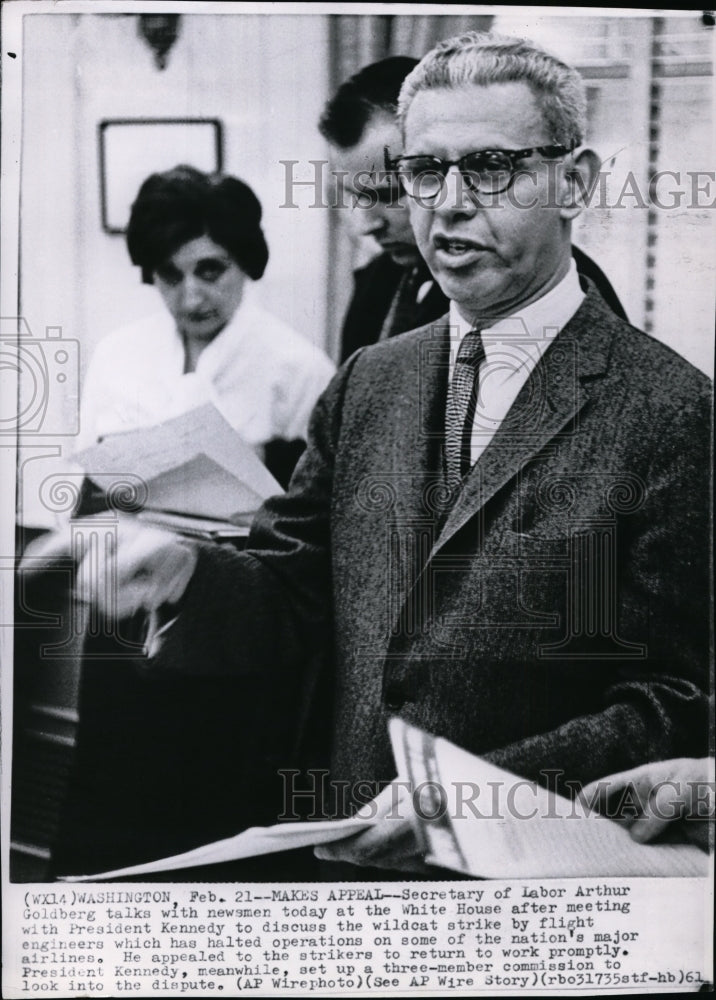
[{"x1": 75, "y1": 284, "x2": 335, "y2": 452}]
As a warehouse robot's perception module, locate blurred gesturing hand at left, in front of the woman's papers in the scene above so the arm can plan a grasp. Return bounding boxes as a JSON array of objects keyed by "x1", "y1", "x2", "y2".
[{"x1": 20, "y1": 515, "x2": 197, "y2": 621}]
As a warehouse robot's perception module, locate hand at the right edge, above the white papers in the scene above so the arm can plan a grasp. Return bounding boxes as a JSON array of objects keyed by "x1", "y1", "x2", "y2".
[{"x1": 581, "y1": 757, "x2": 714, "y2": 850}]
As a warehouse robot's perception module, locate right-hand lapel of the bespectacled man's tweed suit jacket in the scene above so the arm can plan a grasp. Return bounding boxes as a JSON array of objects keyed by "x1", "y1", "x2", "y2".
[{"x1": 431, "y1": 292, "x2": 614, "y2": 558}]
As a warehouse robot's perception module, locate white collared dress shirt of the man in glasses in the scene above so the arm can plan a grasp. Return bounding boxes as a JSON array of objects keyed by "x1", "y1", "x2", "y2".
[{"x1": 449, "y1": 261, "x2": 584, "y2": 465}]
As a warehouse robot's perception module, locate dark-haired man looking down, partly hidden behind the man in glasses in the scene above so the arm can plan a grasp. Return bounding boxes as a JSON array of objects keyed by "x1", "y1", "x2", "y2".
[{"x1": 318, "y1": 56, "x2": 627, "y2": 361}]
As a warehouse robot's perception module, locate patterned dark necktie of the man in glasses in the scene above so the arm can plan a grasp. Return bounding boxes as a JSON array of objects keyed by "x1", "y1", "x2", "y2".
[{"x1": 445, "y1": 330, "x2": 485, "y2": 490}]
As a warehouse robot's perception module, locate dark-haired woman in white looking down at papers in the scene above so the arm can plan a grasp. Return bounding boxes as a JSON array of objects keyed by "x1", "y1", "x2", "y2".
[{"x1": 78, "y1": 166, "x2": 335, "y2": 481}]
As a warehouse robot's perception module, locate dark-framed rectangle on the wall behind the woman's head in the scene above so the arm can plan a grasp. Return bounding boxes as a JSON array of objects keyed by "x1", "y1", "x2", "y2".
[{"x1": 98, "y1": 118, "x2": 223, "y2": 233}]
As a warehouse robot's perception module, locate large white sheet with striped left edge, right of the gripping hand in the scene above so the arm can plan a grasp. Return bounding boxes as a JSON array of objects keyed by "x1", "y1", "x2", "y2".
[{"x1": 390, "y1": 718, "x2": 709, "y2": 878}]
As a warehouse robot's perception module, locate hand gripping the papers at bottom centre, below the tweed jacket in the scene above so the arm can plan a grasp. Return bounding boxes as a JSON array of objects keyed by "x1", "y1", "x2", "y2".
[{"x1": 314, "y1": 782, "x2": 429, "y2": 873}]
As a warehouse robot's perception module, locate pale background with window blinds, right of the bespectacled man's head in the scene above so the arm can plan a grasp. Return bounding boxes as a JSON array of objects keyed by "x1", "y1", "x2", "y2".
[{"x1": 495, "y1": 8, "x2": 716, "y2": 375}]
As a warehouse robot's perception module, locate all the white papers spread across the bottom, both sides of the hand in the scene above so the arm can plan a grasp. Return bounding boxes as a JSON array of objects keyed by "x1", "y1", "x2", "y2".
[{"x1": 62, "y1": 718, "x2": 709, "y2": 882}]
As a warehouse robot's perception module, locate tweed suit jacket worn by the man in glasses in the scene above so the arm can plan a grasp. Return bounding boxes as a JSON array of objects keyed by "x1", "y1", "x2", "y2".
[{"x1": 164, "y1": 290, "x2": 710, "y2": 816}]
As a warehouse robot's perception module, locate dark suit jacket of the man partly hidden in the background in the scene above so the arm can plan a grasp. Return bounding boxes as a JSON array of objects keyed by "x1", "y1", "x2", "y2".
[{"x1": 341, "y1": 247, "x2": 627, "y2": 362}]
